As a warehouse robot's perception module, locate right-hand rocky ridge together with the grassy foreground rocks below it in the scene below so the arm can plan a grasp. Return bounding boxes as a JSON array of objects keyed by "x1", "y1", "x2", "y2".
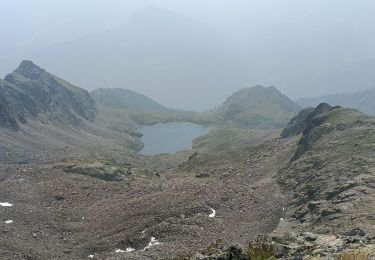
[{"x1": 186, "y1": 104, "x2": 375, "y2": 259}]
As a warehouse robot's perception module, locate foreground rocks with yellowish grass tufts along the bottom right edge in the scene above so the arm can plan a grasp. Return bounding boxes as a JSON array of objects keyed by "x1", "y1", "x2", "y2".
[{"x1": 191, "y1": 234, "x2": 375, "y2": 260}]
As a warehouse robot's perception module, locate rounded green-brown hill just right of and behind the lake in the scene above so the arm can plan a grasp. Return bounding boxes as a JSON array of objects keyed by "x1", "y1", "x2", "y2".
[{"x1": 207, "y1": 86, "x2": 301, "y2": 128}]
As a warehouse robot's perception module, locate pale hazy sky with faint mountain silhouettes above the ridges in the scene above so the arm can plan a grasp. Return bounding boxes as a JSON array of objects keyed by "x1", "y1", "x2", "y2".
[{"x1": 0, "y1": 0, "x2": 375, "y2": 110}]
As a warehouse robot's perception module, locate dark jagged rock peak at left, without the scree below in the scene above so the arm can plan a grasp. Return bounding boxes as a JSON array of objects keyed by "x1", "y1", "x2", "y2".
[{"x1": 0, "y1": 61, "x2": 97, "y2": 130}]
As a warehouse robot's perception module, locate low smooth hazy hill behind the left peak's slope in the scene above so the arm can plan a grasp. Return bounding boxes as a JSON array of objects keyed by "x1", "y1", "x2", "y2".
[{"x1": 91, "y1": 88, "x2": 170, "y2": 112}]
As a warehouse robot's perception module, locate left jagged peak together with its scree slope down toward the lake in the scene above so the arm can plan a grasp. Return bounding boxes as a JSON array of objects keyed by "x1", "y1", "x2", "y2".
[{"x1": 0, "y1": 61, "x2": 143, "y2": 162}]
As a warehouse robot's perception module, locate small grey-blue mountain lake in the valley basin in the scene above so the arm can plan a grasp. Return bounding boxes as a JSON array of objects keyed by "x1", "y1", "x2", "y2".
[{"x1": 139, "y1": 122, "x2": 208, "y2": 155}]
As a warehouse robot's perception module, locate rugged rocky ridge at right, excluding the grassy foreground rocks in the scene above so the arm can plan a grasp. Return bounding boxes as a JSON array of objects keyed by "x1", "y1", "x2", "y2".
[{"x1": 277, "y1": 104, "x2": 375, "y2": 234}]
